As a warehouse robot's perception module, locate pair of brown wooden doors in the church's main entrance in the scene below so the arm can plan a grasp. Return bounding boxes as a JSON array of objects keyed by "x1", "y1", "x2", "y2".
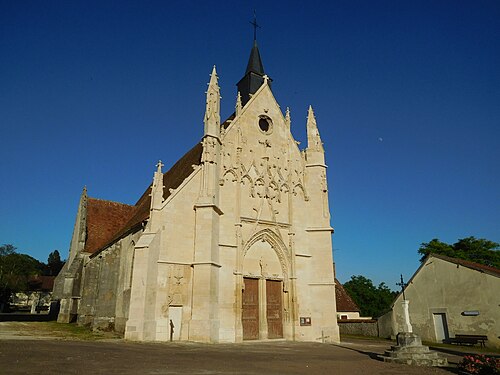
[{"x1": 241, "y1": 278, "x2": 283, "y2": 340}]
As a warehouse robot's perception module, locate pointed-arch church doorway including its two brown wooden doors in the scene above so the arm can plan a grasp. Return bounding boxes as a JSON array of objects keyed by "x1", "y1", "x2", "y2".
[{"x1": 241, "y1": 230, "x2": 287, "y2": 340}]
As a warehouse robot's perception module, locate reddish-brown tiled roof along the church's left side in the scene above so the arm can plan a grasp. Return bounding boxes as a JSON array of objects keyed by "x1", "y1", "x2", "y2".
[{"x1": 85, "y1": 143, "x2": 203, "y2": 256}]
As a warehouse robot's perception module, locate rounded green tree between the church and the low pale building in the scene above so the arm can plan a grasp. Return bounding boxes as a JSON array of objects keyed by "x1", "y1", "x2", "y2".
[{"x1": 344, "y1": 275, "x2": 397, "y2": 317}]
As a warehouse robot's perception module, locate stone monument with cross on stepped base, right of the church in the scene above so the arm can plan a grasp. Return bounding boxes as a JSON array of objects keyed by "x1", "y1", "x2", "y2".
[{"x1": 380, "y1": 275, "x2": 448, "y2": 366}]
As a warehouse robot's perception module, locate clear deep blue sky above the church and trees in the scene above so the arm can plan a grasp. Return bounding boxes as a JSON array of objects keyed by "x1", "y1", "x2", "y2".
[{"x1": 0, "y1": 0, "x2": 500, "y2": 289}]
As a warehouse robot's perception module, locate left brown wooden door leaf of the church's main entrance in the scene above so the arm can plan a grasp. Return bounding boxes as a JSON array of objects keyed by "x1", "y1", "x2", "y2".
[{"x1": 241, "y1": 277, "x2": 259, "y2": 340}]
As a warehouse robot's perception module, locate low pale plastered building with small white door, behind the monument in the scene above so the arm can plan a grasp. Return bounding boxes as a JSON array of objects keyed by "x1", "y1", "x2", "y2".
[{"x1": 379, "y1": 254, "x2": 500, "y2": 348}]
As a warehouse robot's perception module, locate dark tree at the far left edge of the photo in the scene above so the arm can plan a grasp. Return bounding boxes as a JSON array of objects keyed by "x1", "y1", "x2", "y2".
[{"x1": 0, "y1": 244, "x2": 43, "y2": 311}]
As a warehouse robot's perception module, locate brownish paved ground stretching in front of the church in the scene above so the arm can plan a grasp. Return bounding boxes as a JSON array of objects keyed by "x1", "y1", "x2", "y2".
[{"x1": 0, "y1": 323, "x2": 459, "y2": 375}]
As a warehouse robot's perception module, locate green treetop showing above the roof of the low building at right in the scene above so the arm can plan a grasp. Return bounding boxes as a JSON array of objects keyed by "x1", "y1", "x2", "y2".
[{"x1": 418, "y1": 237, "x2": 500, "y2": 269}]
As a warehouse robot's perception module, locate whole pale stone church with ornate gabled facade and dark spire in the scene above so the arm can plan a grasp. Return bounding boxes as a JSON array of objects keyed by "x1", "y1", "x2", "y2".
[{"x1": 54, "y1": 41, "x2": 339, "y2": 343}]
